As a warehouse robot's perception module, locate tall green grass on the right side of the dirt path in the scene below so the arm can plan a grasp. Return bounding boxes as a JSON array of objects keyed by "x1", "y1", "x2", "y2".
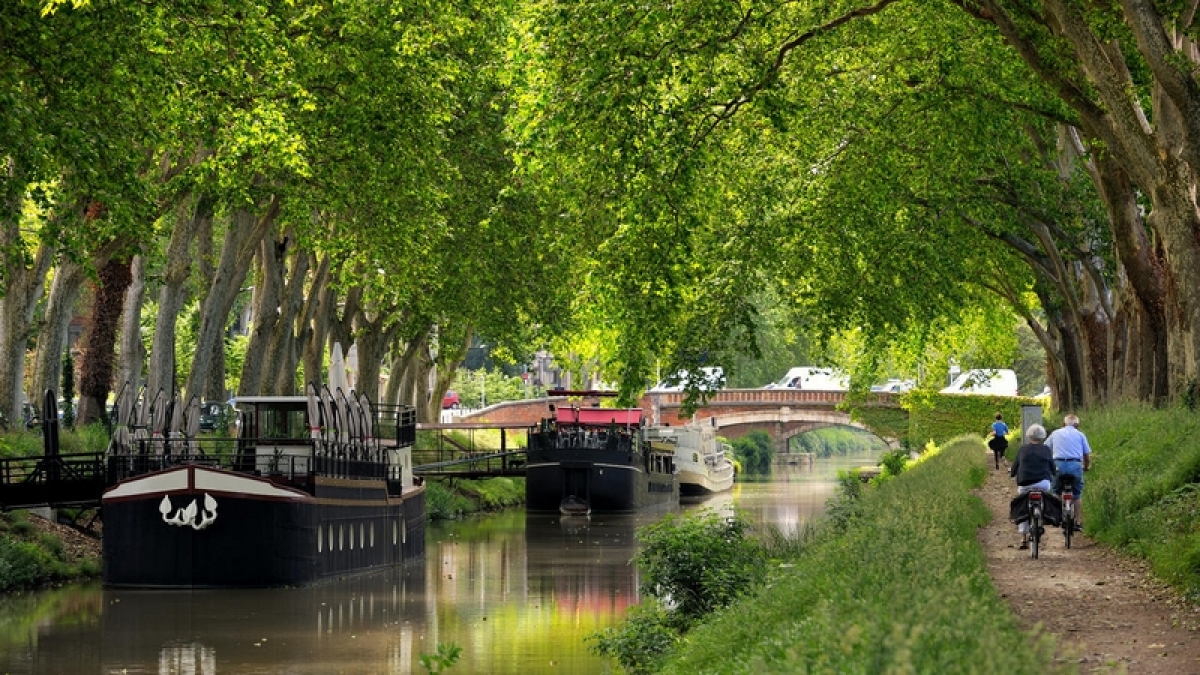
[{"x1": 1080, "y1": 405, "x2": 1200, "y2": 601}]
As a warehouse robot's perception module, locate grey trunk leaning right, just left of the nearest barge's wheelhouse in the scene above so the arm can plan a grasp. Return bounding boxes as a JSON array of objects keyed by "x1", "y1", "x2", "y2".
[{"x1": 187, "y1": 197, "x2": 280, "y2": 395}]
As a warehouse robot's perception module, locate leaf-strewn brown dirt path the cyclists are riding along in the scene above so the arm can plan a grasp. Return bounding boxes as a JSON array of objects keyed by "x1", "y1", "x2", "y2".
[{"x1": 978, "y1": 452, "x2": 1200, "y2": 675}]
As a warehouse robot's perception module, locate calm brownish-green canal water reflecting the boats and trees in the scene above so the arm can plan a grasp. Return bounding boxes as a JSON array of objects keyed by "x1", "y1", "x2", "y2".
[{"x1": 0, "y1": 455, "x2": 877, "y2": 675}]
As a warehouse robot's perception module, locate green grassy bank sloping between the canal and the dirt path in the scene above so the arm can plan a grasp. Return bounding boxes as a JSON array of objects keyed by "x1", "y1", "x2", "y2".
[{"x1": 664, "y1": 440, "x2": 1054, "y2": 674}]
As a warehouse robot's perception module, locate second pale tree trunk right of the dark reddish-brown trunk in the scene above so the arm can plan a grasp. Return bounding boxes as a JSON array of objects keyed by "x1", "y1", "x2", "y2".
[{"x1": 146, "y1": 196, "x2": 214, "y2": 394}]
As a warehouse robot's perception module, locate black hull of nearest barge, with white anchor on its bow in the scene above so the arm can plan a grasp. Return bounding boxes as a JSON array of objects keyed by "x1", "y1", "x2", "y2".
[{"x1": 102, "y1": 466, "x2": 425, "y2": 589}]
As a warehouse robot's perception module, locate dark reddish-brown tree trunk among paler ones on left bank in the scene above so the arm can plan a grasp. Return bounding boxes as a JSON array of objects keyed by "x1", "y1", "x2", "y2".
[{"x1": 76, "y1": 259, "x2": 133, "y2": 425}]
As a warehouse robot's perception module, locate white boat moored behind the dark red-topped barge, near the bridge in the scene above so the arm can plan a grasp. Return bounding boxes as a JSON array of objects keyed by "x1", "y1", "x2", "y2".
[{"x1": 646, "y1": 423, "x2": 733, "y2": 497}]
